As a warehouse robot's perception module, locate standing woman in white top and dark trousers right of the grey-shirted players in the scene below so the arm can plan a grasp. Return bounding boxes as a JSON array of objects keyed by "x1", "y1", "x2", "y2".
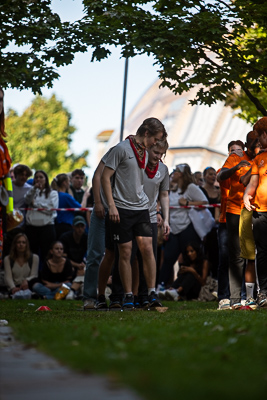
[{"x1": 159, "y1": 164, "x2": 208, "y2": 286}]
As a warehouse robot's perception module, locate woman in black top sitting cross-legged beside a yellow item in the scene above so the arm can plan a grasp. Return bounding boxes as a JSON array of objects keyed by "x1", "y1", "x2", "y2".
[{"x1": 33, "y1": 241, "x2": 74, "y2": 300}]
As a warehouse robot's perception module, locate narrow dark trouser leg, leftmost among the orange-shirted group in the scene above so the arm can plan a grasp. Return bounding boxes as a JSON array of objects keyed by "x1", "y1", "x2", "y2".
[{"x1": 218, "y1": 223, "x2": 230, "y2": 301}]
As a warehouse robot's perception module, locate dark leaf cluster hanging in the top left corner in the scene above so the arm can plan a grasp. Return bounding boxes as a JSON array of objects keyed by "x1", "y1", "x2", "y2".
[{"x1": 0, "y1": 0, "x2": 87, "y2": 93}]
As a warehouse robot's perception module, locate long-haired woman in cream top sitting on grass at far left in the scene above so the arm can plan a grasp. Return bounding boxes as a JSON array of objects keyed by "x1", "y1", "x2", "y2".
[{"x1": 4, "y1": 233, "x2": 39, "y2": 299}]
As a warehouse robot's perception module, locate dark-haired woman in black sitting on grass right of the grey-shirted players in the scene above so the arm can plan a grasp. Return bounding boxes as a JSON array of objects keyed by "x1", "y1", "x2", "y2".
[{"x1": 159, "y1": 243, "x2": 209, "y2": 301}]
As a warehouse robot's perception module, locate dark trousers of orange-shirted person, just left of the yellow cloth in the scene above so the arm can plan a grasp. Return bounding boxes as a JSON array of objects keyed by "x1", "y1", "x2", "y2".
[{"x1": 226, "y1": 213, "x2": 245, "y2": 304}]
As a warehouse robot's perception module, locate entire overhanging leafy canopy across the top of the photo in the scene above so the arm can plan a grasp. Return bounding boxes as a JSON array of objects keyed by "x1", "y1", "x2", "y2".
[{"x1": 0, "y1": 0, "x2": 267, "y2": 120}]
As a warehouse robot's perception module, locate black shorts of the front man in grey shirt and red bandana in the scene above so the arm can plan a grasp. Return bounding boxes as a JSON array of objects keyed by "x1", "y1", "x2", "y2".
[{"x1": 110, "y1": 208, "x2": 152, "y2": 243}]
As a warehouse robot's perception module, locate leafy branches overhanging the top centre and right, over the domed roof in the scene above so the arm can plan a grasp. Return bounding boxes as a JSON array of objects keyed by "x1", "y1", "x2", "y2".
[{"x1": 81, "y1": 0, "x2": 267, "y2": 119}]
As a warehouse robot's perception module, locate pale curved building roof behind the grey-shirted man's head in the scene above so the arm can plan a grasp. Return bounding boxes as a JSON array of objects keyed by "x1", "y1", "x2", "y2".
[{"x1": 99, "y1": 80, "x2": 252, "y2": 171}]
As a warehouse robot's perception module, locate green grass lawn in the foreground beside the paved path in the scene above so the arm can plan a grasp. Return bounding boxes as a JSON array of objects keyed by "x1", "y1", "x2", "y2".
[{"x1": 0, "y1": 300, "x2": 267, "y2": 400}]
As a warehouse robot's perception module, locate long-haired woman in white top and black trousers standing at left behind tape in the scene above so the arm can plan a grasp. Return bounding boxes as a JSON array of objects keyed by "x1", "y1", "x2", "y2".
[{"x1": 25, "y1": 170, "x2": 58, "y2": 264}]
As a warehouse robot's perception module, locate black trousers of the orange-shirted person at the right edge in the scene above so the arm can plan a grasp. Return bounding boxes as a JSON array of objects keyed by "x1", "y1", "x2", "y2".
[{"x1": 252, "y1": 211, "x2": 267, "y2": 295}]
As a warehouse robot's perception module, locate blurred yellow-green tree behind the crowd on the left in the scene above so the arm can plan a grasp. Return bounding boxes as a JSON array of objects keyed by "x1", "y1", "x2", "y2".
[{"x1": 6, "y1": 95, "x2": 88, "y2": 177}]
